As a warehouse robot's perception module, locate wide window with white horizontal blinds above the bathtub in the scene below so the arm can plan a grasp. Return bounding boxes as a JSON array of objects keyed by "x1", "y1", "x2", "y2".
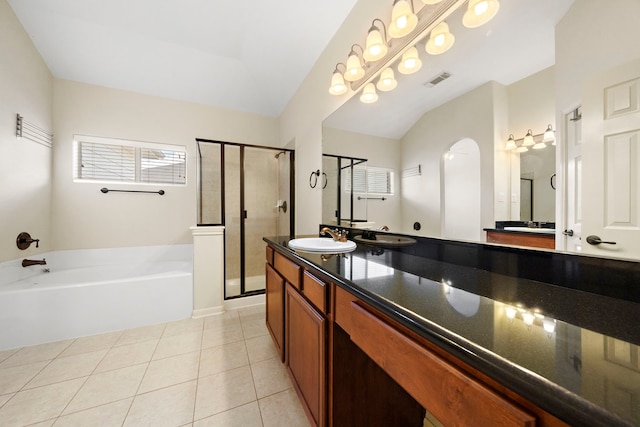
[{"x1": 74, "y1": 135, "x2": 187, "y2": 184}]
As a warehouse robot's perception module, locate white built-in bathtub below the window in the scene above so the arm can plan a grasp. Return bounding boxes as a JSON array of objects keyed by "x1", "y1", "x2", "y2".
[{"x1": 0, "y1": 245, "x2": 193, "y2": 351}]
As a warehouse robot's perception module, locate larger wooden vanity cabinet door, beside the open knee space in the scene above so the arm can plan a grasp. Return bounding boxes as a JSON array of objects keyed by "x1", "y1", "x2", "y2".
[{"x1": 286, "y1": 284, "x2": 327, "y2": 426}]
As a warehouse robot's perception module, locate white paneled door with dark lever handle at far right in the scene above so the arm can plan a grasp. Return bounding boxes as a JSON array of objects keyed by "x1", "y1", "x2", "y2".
[{"x1": 582, "y1": 60, "x2": 640, "y2": 259}]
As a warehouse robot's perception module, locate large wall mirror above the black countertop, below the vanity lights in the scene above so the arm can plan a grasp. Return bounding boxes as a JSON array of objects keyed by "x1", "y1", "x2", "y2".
[{"x1": 323, "y1": 0, "x2": 640, "y2": 260}]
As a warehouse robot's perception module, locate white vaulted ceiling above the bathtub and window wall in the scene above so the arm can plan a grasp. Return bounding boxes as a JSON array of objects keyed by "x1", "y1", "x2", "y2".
[{"x1": 8, "y1": 0, "x2": 356, "y2": 117}]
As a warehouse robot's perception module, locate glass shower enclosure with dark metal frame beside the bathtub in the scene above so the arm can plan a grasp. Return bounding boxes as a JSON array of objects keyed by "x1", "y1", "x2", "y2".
[{"x1": 196, "y1": 139, "x2": 294, "y2": 299}]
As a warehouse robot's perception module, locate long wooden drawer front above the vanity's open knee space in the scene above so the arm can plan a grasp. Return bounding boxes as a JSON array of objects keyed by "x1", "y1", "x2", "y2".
[{"x1": 348, "y1": 302, "x2": 536, "y2": 427}]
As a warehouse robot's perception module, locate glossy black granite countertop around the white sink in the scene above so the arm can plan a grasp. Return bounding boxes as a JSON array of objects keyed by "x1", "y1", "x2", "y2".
[{"x1": 264, "y1": 237, "x2": 640, "y2": 426}]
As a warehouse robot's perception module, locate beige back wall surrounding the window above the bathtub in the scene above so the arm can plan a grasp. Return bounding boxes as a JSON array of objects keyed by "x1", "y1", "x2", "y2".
[{"x1": 52, "y1": 79, "x2": 279, "y2": 249}]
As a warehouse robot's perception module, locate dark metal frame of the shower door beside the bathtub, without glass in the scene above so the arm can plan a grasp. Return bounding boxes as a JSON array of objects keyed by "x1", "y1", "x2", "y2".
[{"x1": 196, "y1": 138, "x2": 295, "y2": 300}]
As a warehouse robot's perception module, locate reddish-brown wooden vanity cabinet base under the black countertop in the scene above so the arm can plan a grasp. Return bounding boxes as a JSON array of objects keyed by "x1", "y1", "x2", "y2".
[{"x1": 267, "y1": 244, "x2": 567, "y2": 427}]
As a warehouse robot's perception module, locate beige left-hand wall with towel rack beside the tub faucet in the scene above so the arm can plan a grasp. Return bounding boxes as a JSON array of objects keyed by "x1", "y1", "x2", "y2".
[{"x1": 0, "y1": 0, "x2": 53, "y2": 262}]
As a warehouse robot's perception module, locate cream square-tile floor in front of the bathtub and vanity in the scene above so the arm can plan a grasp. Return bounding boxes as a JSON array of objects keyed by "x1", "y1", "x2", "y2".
[{"x1": 0, "y1": 305, "x2": 309, "y2": 427}]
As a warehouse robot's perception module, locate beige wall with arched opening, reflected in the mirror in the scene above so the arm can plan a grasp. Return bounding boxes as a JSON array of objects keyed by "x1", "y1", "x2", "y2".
[{"x1": 401, "y1": 82, "x2": 506, "y2": 237}]
